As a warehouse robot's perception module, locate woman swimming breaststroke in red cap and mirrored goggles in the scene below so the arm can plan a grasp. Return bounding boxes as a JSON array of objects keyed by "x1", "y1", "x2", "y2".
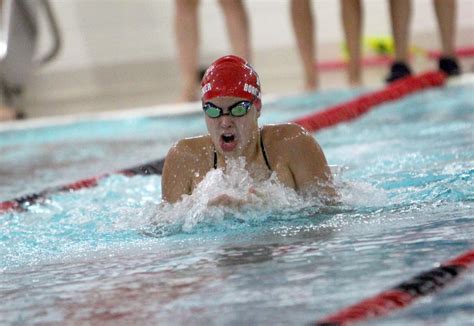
[{"x1": 162, "y1": 55, "x2": 337, "y2": 207}]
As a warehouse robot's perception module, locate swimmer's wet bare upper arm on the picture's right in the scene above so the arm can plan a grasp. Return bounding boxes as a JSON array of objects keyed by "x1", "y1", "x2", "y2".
[{"x1": 287, "y1": 126, "x2": 338, "y2": 204}]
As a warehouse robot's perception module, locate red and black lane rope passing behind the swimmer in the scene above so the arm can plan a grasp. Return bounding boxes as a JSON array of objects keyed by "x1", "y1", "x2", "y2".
[{"x1": 0, "y1": 71, "x2": 446, "y2": 213}]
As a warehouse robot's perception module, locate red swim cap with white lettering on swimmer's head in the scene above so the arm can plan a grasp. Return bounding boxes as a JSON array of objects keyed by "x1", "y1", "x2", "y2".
[{"x1": 201, "y1": 55, "x2": 262, "y2": 110}]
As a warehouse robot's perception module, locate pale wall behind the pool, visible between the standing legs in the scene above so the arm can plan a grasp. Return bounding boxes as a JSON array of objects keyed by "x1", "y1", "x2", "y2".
[{"x1": 25, "y1": 0, "x2": 474, "y2": 115}]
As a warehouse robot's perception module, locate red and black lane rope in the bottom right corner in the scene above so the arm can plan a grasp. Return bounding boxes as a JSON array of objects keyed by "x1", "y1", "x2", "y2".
[{"x1": 316, "y1": 250, "x2": 474, "y2": 326}]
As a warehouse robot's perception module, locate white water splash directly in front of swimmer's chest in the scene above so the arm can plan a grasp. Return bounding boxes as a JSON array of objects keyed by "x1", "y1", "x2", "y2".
[{"x1": 146, "y1": 158, "x2": 312, "y2": 232}]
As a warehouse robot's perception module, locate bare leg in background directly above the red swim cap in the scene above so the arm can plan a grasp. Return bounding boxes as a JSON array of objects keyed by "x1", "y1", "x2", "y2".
[{"x1": 219, "y1": 0, "x2": 251, "y2": 61}]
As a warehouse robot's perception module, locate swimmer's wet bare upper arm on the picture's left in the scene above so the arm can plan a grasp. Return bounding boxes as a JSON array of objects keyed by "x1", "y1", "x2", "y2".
[{"x1": 161, "y1": 141, "x2": 194, "y2": 203}]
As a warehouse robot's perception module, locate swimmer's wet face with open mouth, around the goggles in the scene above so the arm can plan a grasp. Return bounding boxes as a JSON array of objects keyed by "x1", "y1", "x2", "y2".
[{"x1": 204, "y1": 96, "x2": 260, "y2": 157}]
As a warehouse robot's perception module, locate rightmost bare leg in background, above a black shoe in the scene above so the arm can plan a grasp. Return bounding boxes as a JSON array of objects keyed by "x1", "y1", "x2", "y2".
[{"x1": 433, "y1": 0, "x2": 456, "y2": 57}]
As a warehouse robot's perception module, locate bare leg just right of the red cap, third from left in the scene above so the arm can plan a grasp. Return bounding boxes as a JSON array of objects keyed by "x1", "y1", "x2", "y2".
[{"x1": 290, "y1": 0, "x2": 318, "y2": 90}]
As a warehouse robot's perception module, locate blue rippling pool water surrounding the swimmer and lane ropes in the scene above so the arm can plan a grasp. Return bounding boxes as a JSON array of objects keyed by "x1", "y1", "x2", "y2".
[{"x1": 0, "y1": 85, "x2": 474, "y2": 325}]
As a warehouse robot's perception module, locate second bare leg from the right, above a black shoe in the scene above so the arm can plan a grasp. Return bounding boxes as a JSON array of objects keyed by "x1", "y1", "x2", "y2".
[{"x1": 390, "y1": 0, "x2": 411, "y2": 63}]
